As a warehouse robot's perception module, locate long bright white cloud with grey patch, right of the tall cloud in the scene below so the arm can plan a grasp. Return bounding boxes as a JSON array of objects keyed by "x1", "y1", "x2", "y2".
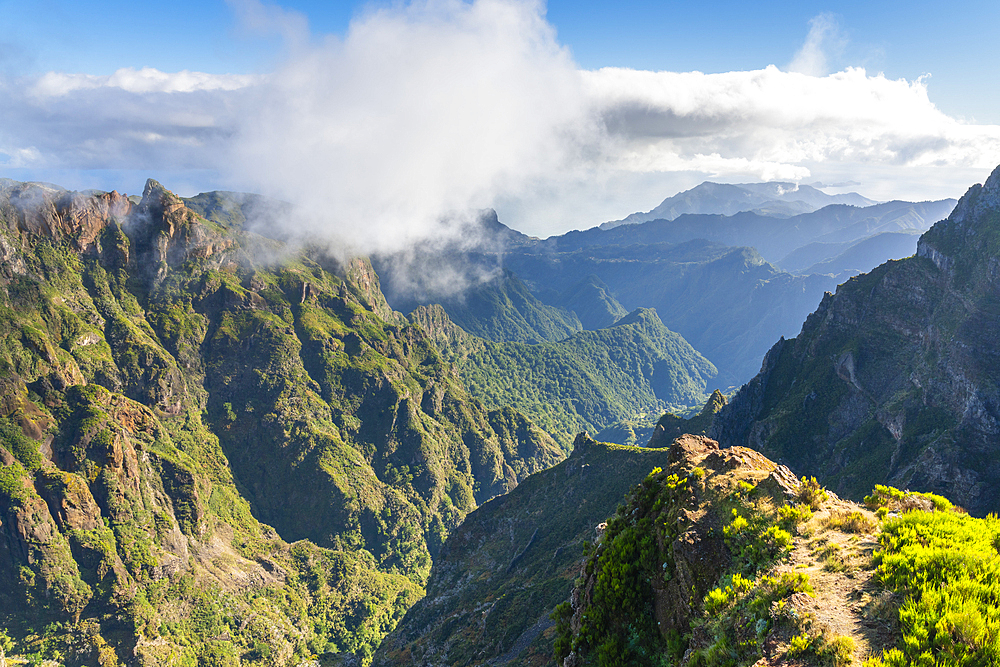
[{"x1": 583, "y1": 66, "x2": 1000, "y2": 172}]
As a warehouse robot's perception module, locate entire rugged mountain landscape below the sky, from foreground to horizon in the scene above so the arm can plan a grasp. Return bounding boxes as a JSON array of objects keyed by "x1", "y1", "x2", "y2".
[{"x1": 0, "y1": 163, "x2": 1000, "y2": 667}]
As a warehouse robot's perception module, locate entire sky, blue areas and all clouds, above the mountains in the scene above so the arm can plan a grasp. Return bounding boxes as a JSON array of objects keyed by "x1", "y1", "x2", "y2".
[{"x1": 0, "y1": 0, "x2": 1000, "y2": 243}]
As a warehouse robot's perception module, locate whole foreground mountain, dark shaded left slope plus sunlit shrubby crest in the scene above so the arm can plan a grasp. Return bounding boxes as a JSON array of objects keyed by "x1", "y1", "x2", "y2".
[{"x1": 374, "y1": 428, "x2": 972, "y2": 667}]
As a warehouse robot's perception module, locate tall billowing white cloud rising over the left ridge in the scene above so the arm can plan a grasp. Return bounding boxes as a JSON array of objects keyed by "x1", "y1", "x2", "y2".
[{"x1": 229, "y1": 0, "x2": 599, "y2": 249}]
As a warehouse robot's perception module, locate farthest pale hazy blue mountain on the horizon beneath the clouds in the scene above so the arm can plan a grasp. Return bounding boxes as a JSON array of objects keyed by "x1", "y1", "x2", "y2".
[{"x1": 600, "y1": 181, "x2": 875, "y2": 229}]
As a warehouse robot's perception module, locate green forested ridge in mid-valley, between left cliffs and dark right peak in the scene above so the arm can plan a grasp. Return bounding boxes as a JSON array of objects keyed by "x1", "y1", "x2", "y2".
[{"x1": 410, "y1": 306, "x2": 716, "y2": 448}]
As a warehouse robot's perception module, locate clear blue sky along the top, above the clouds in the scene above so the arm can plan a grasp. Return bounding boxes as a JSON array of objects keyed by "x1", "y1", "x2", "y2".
[{"x1": 9, "y1": 0, "x2": 1000, "y2": 123}]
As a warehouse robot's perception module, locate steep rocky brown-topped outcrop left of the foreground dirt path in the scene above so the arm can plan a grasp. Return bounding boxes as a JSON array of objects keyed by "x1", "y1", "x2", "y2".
[{"x1": 555, "y1": 435, "x2": 820, "y2": 666}]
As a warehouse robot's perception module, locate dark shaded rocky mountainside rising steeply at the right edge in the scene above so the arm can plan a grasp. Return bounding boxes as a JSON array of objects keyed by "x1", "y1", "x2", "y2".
[{"x1": 712, "y1": 163, "x2": 1000, "y2": 514}]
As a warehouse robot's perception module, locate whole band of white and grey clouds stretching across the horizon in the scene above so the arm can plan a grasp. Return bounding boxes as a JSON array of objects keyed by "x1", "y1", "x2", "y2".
[{"x1": 0, "y1": 0, "x2": 1000, "y2": 245}]
